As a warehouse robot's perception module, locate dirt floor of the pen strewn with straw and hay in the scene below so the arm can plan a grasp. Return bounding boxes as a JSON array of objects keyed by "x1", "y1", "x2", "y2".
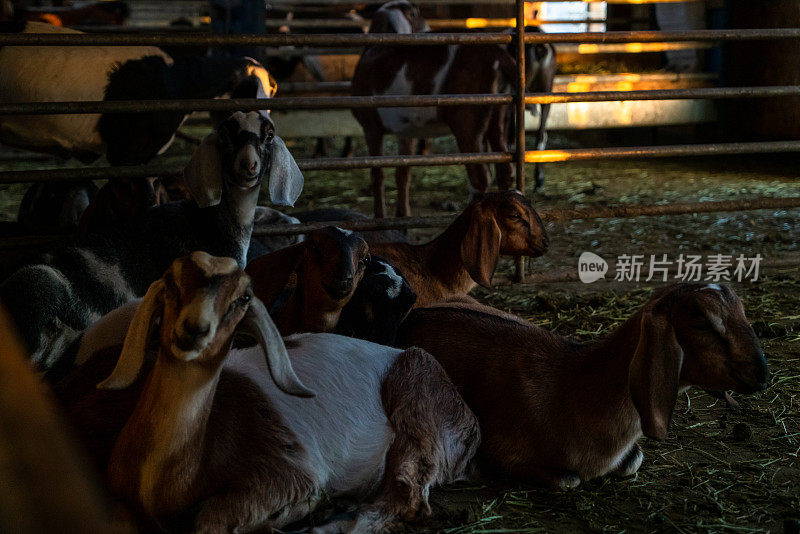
[{"x1": 0, "y1": 131, "x2": 800, "y2": 534}]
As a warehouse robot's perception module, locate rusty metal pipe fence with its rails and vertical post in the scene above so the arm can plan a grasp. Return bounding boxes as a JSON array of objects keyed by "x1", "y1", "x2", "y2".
[{"x1": 0, "y1": 19, "x2": 800, "y2": 276}]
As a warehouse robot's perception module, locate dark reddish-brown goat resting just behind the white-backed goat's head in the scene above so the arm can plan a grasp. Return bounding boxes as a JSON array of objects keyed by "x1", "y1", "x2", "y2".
[{"x1": 245, "y1": 226, "x2": 369, "y2": 336}]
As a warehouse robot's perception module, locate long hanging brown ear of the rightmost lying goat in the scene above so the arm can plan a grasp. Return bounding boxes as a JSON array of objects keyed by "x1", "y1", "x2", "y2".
[{"x1": 628, "y1": 310, "x2": 683, "y2": 440}]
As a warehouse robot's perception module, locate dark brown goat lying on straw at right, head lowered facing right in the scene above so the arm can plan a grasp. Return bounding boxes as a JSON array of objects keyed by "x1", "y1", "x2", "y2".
[{"x1": 397, "y1": 284, "x2": 767, "y2": 488}]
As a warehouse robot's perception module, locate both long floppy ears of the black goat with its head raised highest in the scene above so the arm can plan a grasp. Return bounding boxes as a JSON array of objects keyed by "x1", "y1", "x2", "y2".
[{"x1": 184, "y1": 112, "x2": 304, "y2": 208}]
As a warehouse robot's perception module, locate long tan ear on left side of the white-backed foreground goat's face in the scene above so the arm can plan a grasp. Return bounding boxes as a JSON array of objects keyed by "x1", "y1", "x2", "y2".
[{"x1": 97, "y1": 279, "x2": 164, "y2": 389}]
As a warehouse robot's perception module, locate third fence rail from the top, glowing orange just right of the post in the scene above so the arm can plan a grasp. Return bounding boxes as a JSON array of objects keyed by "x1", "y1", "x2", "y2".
[{"x1": 0, "y1": 141, "x2": 800, "y2": 184}]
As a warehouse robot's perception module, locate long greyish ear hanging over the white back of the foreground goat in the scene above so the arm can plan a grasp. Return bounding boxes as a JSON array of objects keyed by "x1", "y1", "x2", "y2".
[{"x1": 239, "y1": 298, "x2": 314, "y2": 397}]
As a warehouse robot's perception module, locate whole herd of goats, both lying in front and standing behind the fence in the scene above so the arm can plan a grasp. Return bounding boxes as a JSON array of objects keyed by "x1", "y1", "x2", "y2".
[{"x1": 0, "y1": 1, "x2": 767, "y2": 532}]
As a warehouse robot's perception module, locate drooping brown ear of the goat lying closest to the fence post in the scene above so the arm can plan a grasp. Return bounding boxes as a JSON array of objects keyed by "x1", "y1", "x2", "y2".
[{"x1": 461, "y1": 211, "x2": 502, "y2": 287}]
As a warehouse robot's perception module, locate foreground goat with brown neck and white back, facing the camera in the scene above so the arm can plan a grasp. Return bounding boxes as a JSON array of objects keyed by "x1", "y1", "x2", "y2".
[{"x1": 65, "y1": 252, "x2": 479, "y2": 532}]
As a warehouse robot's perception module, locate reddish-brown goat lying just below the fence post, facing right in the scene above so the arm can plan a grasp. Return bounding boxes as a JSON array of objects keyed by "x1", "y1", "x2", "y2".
[{"x1": 370, "y1": 191, "x2": 549, "y2": 307}]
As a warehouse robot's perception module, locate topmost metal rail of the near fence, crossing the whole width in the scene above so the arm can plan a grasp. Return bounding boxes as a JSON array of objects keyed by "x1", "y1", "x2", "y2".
[{"x1": 0, "y1": 28, "x2": 800, "y2": 46}]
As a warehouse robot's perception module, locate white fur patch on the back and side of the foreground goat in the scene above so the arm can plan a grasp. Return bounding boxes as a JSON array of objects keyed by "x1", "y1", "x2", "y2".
[{"x1": 225, "y1": 334, "x2": 402, "y2": 495}]
